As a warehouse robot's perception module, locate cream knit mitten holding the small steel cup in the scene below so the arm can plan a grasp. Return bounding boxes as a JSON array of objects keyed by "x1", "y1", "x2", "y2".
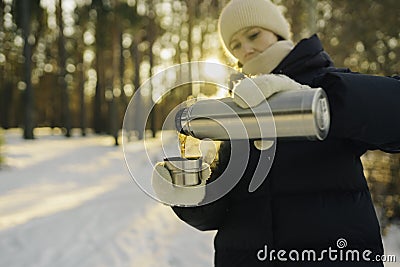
[{"x1": 151, "y1": 162, "x2": 211, "y2": 206}]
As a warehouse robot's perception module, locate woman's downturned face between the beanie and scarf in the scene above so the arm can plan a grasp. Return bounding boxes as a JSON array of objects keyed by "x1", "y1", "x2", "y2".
[{"x1": 229, "y1": 27, "x2": 278, "y2": 64}]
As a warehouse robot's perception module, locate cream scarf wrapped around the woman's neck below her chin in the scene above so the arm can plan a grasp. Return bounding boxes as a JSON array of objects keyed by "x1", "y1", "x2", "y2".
[{"x1": 242, "y1": 40, "x2": 294, "y2": 75}]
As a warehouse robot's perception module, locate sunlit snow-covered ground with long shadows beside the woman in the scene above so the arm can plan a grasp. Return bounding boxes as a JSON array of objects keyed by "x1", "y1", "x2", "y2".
[{"x1": 0, "y1": 129, "x2": 400, "y2": 267}]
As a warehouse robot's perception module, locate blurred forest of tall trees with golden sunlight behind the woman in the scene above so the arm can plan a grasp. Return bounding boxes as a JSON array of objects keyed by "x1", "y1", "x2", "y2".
[{"x1": 0, "y1": 0, "x2": 400, "y2": 231}]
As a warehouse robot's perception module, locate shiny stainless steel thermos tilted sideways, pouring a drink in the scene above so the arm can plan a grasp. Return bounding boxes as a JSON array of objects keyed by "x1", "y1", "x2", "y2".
[{"x1": 175, "y1": 88, "x2": 330, "y2": 140}]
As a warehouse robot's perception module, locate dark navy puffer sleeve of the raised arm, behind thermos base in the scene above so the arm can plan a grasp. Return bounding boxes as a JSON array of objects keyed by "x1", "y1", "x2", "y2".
[{"x1": 318, "y1": 72, "x2": 400, "y2": 152}]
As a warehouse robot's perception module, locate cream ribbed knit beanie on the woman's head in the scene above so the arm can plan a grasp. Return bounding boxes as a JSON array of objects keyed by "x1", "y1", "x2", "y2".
[{"x1": 218, "y1": 0, "x2": 291, "y2": 59}]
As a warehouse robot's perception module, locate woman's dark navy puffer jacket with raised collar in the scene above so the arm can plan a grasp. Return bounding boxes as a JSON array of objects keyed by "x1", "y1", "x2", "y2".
[{"x1": 173, "y1": 35, "x2": 400, "y2": 267}]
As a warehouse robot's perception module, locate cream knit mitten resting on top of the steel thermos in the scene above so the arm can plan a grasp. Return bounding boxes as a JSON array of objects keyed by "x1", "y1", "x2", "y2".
[{"x1": 233, "y1": 74, "x2": 310, "y2": 108}]
